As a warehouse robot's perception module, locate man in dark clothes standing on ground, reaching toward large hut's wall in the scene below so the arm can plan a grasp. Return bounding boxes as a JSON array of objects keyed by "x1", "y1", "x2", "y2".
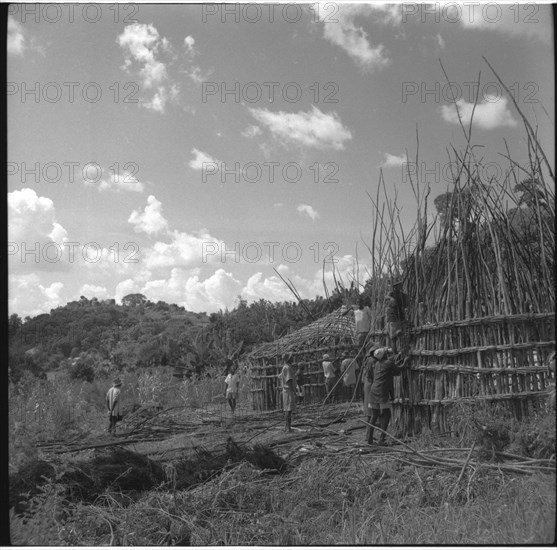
[{"x1": 367, "y1": 348, "x2": 410, "y2": 445}]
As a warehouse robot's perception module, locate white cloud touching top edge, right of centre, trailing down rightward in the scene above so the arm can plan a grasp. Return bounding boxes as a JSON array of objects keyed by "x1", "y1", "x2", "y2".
[{"x1": 317, "y1": 4, "x2": 394, "y2": 72}]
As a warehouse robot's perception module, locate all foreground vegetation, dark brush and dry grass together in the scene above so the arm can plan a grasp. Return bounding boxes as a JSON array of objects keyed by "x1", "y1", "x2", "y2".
[{"x1": 10, "y1": 370, "x2": 556, "y2": 546}]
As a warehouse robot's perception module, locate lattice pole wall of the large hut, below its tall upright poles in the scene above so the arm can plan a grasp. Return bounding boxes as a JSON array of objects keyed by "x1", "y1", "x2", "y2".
[{"x1": 393, "y1": 313, "x2": 555, "y2": 435}]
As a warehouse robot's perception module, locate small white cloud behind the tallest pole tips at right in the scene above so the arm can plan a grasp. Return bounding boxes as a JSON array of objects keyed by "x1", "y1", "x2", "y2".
[{"x1": 441, "y1": 97, "x2": 517, "y2": 130}]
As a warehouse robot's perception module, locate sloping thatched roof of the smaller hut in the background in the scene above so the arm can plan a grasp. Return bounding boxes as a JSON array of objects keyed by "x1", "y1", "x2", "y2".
[{"x1": 248, "y1": 306, "x2": 354, "y2": 360}]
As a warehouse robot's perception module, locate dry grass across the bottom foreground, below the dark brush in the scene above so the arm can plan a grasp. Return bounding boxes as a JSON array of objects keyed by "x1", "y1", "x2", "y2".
[{"x1": 11, "y1": 418, "x2": 556, "y2": 546}]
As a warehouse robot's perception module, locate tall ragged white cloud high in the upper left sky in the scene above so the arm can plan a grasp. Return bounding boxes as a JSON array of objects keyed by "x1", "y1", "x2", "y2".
[{"x1": 116, "y1": 23, "x2": 179, "y2": 113}]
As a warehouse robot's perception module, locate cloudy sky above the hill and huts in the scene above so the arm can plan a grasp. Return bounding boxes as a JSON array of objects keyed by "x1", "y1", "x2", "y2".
[{"x1": 7, "y1": 2, "x2": 555, "y2": 317}]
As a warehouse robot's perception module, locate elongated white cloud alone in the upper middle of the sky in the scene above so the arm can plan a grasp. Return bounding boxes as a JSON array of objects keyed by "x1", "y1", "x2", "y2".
[{"x1": 249, "y1": 106, "x2": 352, "y2": 150}]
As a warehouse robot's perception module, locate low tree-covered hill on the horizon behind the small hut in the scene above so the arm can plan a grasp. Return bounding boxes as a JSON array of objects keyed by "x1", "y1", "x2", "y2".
[{"x1": 9, "y1": 292, "x2": 343, "y2": 382}]
